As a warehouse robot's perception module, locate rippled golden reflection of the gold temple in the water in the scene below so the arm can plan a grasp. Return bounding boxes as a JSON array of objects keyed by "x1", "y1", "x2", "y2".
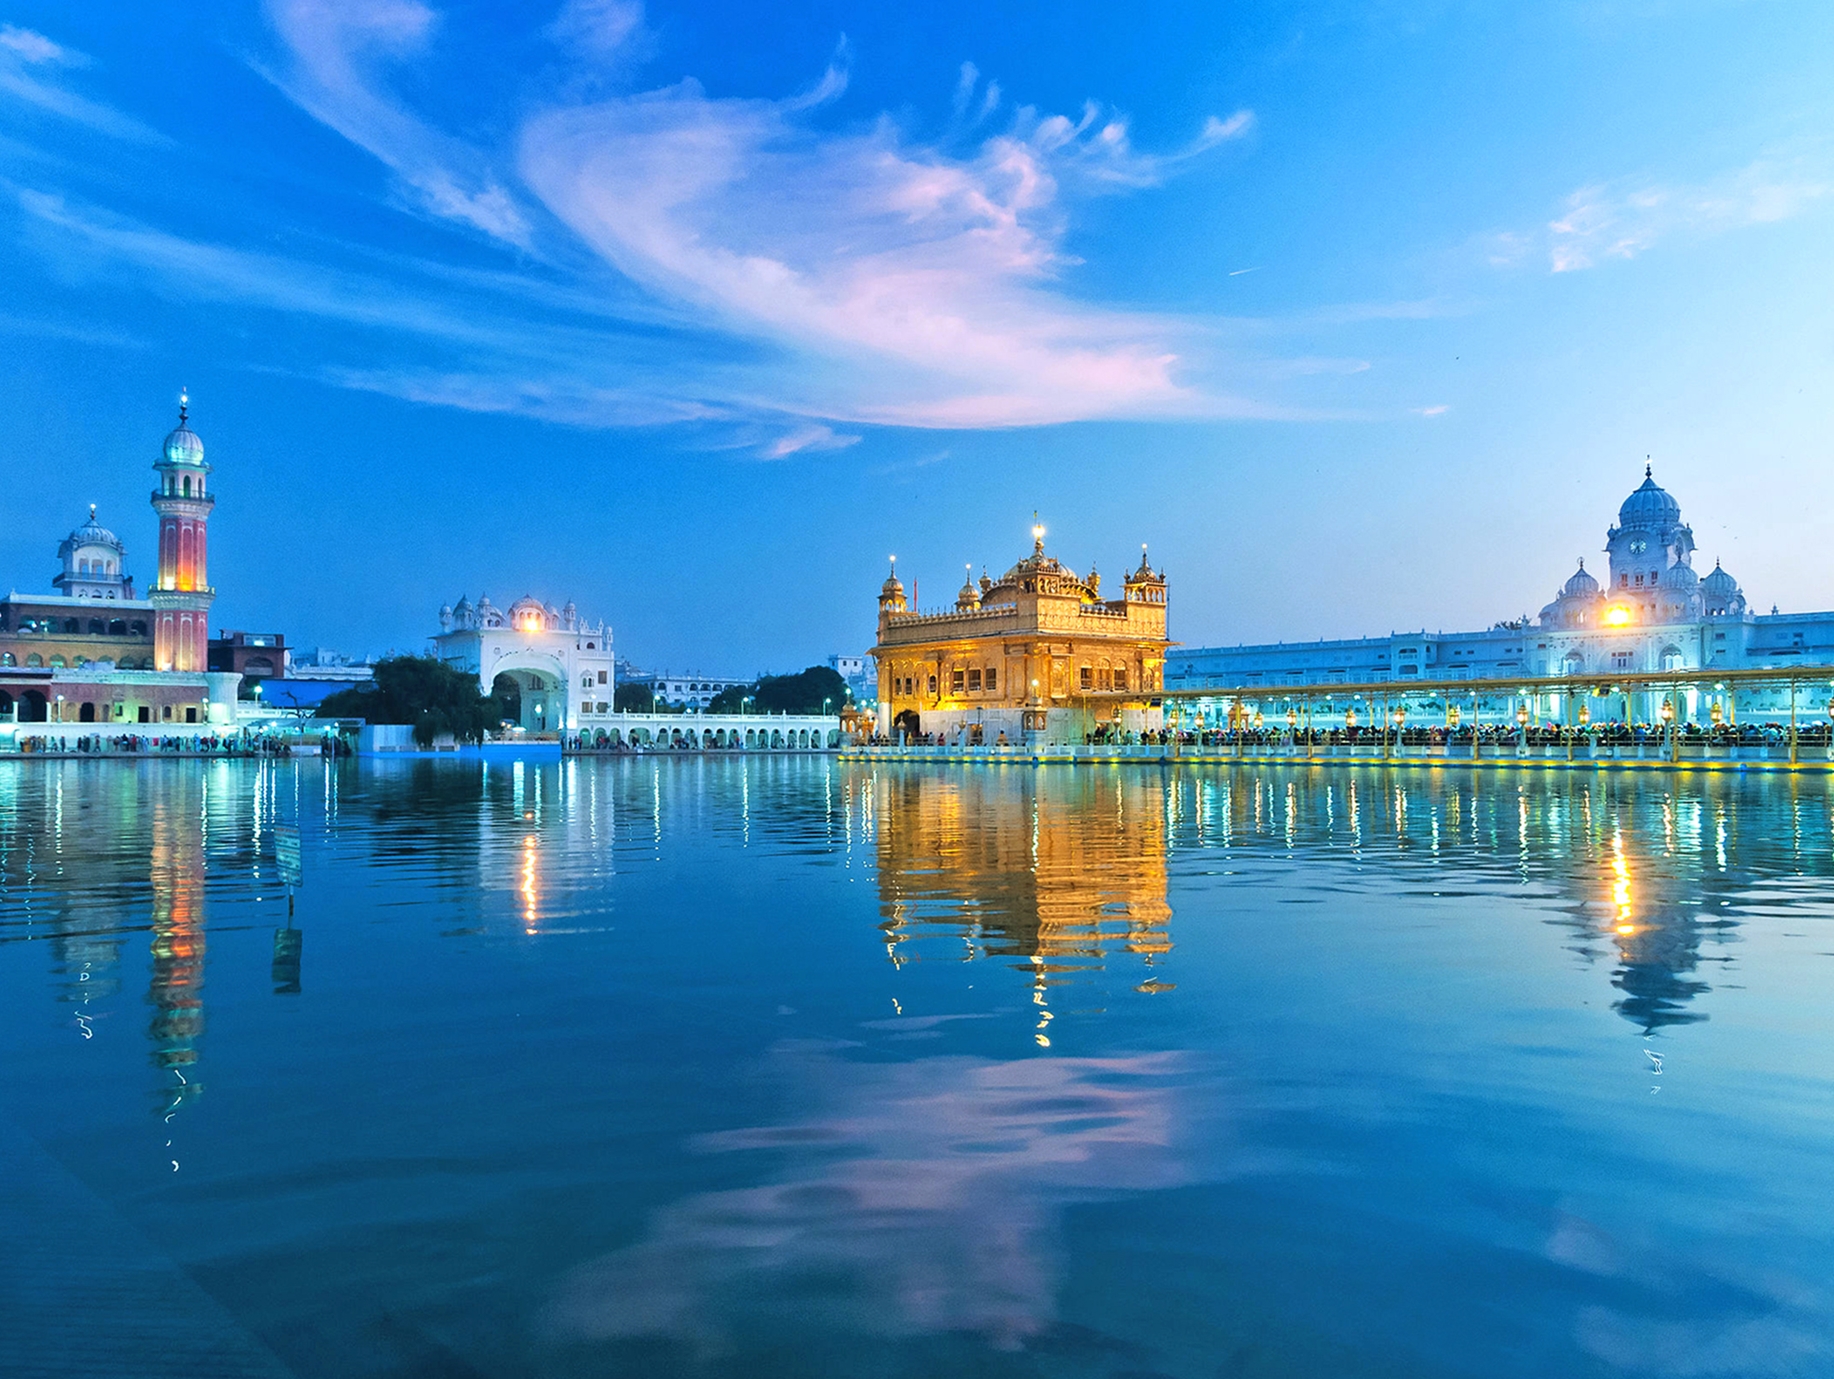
[{"x1": 877, "y1": 772, "x2": 1172, "y2": 987}]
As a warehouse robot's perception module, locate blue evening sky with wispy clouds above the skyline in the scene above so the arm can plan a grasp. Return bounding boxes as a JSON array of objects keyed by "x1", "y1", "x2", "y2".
[{"x1": 0, "y1": 0, "x2": 1834, "y2": 671}]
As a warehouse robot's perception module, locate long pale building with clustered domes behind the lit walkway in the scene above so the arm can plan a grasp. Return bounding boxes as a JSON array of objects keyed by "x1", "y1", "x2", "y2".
[{"x1": 1166, "y1": 468, "x2": 1834, "y2": 690}]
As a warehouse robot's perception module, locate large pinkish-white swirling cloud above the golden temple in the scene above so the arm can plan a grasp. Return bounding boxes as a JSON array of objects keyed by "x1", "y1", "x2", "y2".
[{"x1": 519, "y1": 81, "x2": 1247, "y2": 427}]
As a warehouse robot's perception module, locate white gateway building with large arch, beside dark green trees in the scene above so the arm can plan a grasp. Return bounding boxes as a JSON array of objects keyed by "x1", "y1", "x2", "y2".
[{"x1": 433, "y1": 598, "x2": 616, "y2": 732}]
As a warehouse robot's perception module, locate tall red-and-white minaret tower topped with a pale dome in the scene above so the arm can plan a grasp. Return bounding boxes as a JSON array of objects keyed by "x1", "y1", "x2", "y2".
[{"x1": 147, "y1": 394, "x2": 216, "y2": 675}]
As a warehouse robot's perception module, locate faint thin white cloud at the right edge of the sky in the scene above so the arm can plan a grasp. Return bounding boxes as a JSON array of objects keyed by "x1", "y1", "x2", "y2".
[{"x1": 1511, "y1": 156, "x2": 1834, "y2": 273}]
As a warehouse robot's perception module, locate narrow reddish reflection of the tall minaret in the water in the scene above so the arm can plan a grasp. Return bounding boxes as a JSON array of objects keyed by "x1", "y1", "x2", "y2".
[{"x1": 147, "y1": 772, "x2": 204, "y2": 1106}]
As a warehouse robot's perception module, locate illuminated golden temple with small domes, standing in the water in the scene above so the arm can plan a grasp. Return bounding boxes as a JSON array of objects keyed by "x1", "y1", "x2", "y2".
[{"x1": 873, "y1": 526, "x2": 1168, "y2": 745}]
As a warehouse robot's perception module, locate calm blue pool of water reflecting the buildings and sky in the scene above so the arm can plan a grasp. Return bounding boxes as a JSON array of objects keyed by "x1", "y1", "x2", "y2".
[{"x1": 0, "y1": 757, "x2": 1834, "y2": 1379}]
